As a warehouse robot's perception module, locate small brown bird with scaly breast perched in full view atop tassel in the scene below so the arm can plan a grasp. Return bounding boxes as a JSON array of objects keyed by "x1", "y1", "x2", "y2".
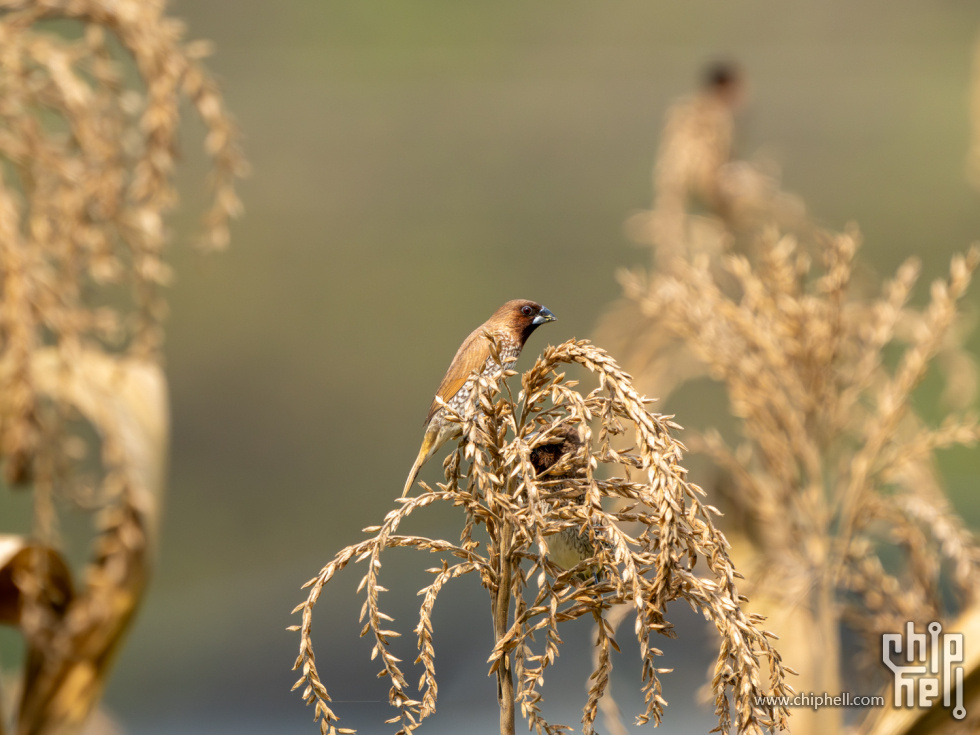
[{"x1": 402, "y1": 299, "x2": 555, "y2": 498}]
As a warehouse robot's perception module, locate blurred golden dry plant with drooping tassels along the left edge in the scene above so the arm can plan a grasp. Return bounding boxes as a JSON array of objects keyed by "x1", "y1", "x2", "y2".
[{"x1": 0, "y1": 0, "x2": 243, "y2": 735}]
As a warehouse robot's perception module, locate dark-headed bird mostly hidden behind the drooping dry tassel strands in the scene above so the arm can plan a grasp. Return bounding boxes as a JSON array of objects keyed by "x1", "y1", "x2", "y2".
[{"x1": 530, "y1": 424, "x2": 605, "y2": 582}]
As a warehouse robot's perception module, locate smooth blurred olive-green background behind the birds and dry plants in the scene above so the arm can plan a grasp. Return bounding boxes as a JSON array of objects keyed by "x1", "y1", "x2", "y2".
[{"x1": 95, "y1": 0, "x2": 980, "y2": 735}]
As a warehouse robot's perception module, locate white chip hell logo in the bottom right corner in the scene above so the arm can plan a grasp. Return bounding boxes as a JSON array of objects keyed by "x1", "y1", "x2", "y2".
[{"x1": 881, "y1": 622, "x2": 966, "y2": 720}]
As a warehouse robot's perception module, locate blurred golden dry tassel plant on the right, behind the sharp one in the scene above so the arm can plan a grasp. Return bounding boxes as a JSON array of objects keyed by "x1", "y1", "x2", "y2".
[{"x1": 599, "y1": 75, "x2": 980, "y2": 733}]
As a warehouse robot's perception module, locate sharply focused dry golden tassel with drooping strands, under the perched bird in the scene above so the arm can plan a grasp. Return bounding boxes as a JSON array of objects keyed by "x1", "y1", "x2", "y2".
[{"x1": 292, "y1": 341, "x2": 789, "y2": 734}]
